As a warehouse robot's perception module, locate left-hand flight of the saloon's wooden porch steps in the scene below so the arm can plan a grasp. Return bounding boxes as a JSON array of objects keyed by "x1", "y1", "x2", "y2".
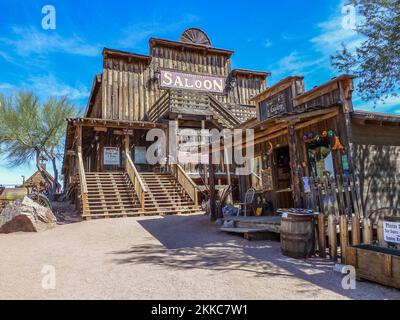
[{"x1": 85, "y1": 172, "x2": 141, "y2": 218}]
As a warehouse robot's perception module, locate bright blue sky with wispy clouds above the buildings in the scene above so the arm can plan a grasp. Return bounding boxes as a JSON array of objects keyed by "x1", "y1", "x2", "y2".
[{"x1": 0, "y1": 0, "x2": 400, "y2": 184}]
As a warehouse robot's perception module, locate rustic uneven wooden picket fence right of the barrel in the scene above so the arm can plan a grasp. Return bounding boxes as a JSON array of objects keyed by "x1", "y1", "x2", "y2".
[{"x1": 303, "y1": 175, "x2": 400, "y2": 264}]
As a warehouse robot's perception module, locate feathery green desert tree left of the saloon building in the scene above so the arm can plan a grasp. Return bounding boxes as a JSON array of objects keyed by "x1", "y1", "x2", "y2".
[{"x1": 0, "y1": 91, "x2": 76, "y2": 198}]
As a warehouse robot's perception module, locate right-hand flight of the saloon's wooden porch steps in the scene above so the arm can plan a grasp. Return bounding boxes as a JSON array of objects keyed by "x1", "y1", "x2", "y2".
[{"x1": 140, "y1": 172, "x2": 199, "y2": 215}]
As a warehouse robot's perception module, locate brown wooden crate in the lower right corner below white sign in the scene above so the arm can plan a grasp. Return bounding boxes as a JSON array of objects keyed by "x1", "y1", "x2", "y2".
[{"x1": 346, "y1": 245, "x2": 400, "y2": 289}]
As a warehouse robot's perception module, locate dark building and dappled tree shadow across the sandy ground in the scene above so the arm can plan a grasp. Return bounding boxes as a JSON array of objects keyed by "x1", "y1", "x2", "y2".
[{"x1": 109, "y1": 212, "x2": 400, "y2": 299}]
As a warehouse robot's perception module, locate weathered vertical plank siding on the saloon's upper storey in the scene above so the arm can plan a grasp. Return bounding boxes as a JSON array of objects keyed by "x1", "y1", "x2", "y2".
[{"x1": 98, "y1": 46, "x2": 265, "y2": 121}]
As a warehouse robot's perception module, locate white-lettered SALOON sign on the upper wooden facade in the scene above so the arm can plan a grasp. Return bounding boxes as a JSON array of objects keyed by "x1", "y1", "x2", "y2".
[{"x1": 160, "y1": 70, "x2": 225, "y2": 93}]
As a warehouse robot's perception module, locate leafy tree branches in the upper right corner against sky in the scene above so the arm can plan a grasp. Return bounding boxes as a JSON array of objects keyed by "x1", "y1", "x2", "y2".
[{"x1": 332, "y1": 0, "x2": 400, "y2": 102}]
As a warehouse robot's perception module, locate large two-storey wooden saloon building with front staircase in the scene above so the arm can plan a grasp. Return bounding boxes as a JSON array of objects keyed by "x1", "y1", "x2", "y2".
[{"x1": 63, "y1": 28, "x2": 269, "y2": 219}]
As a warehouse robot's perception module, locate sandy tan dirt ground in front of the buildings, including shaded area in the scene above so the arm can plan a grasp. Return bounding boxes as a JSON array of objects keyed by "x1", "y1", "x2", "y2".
[{"x1": 0, "y1": 215, "x2": 400, "y2": 300}]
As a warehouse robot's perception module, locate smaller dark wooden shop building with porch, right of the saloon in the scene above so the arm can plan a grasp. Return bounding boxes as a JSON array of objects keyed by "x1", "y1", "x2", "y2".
[{"x1": 239, "y1": 75, "x2": 400, "y2": 217}]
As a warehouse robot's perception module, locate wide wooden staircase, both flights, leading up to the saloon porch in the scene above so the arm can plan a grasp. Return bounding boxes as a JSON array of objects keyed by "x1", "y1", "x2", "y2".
[{"x1": 82, "y1": 172, "x2": 199, "y2": 219}]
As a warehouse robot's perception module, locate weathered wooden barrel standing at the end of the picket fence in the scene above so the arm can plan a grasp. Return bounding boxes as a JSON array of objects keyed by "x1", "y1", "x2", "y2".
[{"x1": 281, "y1": 213, "x2": 314, "y2": 259}]
